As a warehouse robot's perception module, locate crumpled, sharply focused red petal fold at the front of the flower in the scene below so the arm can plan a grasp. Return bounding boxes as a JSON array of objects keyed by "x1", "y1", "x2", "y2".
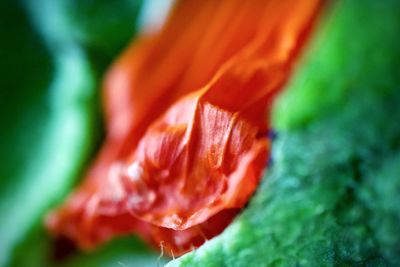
[{"x1": 120, "y1": 92, "x2": 267, "y2": 230}]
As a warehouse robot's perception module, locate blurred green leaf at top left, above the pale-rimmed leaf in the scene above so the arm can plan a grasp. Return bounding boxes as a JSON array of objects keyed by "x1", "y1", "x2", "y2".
[{"x1": 22, "y1": 0, "x2": 141, "y2": 68}]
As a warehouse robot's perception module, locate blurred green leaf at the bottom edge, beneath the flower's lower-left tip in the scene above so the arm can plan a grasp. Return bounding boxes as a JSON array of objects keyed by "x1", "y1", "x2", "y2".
[{"x1": 10, "y1": 229, "x2": 165, "y2": 267}]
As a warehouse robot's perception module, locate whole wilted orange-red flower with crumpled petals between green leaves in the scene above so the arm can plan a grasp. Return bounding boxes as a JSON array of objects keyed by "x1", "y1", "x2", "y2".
[{"x1": 47, "y1": 0, "x2": 319, "y2": 255}]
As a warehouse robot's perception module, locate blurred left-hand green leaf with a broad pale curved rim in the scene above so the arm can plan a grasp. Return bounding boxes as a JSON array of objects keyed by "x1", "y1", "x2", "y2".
[{"x1": 0, "y1": 4, "x2": 96, "y2": 265}]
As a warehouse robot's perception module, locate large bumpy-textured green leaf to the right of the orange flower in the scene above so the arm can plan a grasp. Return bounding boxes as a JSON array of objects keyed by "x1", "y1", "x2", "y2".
[{"x1": 167, "y1": 0, "x2": 400, "y2": 267}]
